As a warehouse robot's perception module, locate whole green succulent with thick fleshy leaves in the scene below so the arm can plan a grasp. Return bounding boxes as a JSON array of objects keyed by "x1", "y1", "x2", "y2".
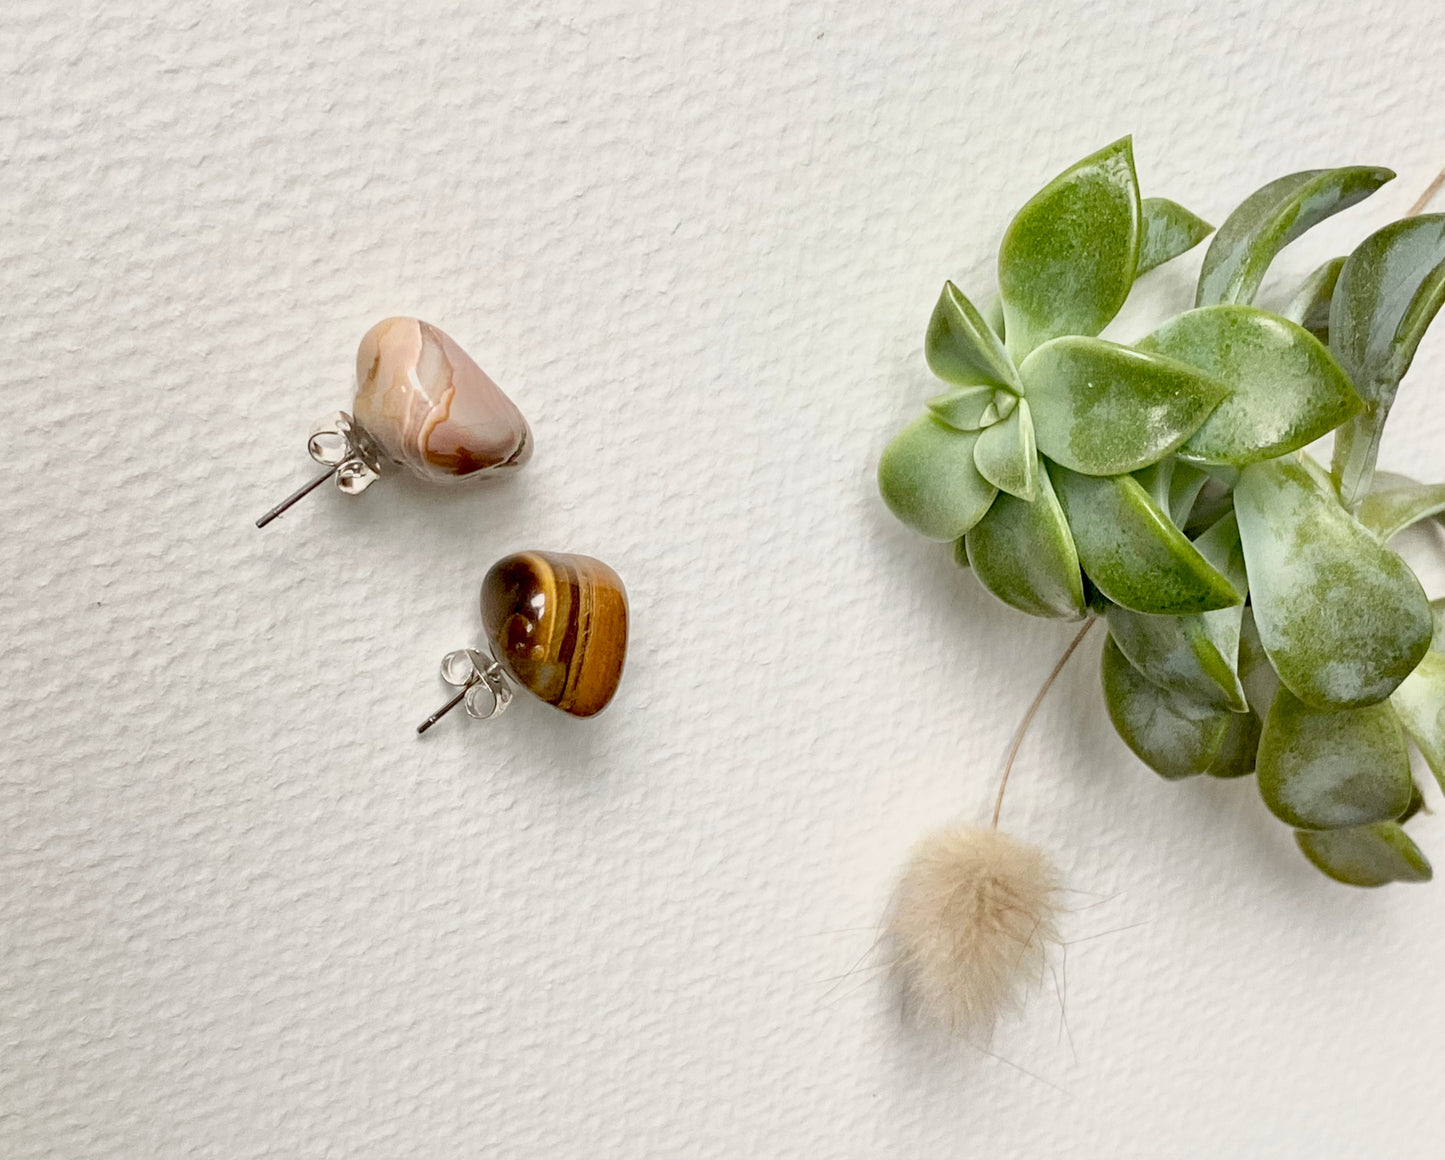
[{"x1": 879, "y1": 139, "x2": 1445, "y2": 886}]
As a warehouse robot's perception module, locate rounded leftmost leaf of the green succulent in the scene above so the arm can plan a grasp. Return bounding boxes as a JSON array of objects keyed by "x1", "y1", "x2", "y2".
[{"x1": 879, "y1": 415, "x2": 998, "y2": 540}]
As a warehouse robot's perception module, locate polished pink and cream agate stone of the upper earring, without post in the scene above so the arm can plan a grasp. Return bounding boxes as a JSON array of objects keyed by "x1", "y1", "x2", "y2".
[{"x1": 354, "y1": 318, "x2": 532, "y2": 484}]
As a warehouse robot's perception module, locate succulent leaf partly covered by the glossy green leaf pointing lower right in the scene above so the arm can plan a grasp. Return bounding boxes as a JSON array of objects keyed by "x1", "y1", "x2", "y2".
[{"x1": 1108, "y1": 516, "x2": 1253, "y2": 713}]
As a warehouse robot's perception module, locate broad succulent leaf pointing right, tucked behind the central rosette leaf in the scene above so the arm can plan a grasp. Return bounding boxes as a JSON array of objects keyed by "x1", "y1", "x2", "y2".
[{"x1": 1139, "y1": 306, "x2": 1363, "y2": 467}]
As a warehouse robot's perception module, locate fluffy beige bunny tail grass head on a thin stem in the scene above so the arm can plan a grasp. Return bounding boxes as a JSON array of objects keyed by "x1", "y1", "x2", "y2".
[{"x1": 884, "y1": 826, "x2": 1059, "y2": 1036}]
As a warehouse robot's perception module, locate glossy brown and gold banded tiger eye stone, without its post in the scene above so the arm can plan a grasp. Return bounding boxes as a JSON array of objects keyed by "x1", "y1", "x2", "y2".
[{"x1": 481, "y1": 552, "x2": 627, "y2": 717}]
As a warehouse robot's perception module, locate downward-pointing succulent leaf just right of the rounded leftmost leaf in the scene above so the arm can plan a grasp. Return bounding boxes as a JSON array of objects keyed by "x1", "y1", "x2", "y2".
[{"x1": 964, "y1": 467, "x2": 1084, "y2": 620}]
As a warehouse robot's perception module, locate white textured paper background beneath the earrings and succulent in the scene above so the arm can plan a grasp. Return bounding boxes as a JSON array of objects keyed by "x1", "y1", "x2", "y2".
[{"x1": 0, "y1": 0, "x2": 1445, "y2": 1160}]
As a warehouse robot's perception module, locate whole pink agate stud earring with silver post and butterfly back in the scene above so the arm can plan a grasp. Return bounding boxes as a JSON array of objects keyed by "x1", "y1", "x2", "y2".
[{"x1": 256, "y1": 318, "x2": 532, "y2": 527}]
